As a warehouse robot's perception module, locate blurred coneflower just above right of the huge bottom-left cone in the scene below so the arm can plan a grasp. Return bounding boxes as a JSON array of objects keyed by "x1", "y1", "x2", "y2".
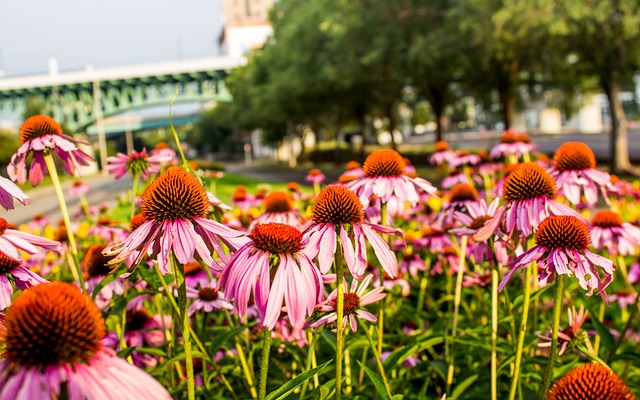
[{"x1": 82, "y1": 244, "x2": 124, "y2": 310}]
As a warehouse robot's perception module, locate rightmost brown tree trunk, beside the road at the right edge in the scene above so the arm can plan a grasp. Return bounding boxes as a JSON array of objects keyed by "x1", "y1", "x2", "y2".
[{"x1": 602, "y1": 82, "x2": 638, "y2": 174}]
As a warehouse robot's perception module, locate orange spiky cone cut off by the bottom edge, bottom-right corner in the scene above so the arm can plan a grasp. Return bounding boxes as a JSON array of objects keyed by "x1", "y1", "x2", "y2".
[{"x1": 545, "y1": 363, "x2": 635, "y2": 400}]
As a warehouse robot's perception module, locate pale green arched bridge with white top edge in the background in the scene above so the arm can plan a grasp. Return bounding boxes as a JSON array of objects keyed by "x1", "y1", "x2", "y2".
[{"x1": 0, "y1": 56, "x2": 244, "y2": 165}]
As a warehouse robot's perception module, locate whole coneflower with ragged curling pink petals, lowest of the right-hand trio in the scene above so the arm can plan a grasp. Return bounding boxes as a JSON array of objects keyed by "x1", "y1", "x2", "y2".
[{"x1": 498, "y1": 215, "x2": 614, "y2": 301}]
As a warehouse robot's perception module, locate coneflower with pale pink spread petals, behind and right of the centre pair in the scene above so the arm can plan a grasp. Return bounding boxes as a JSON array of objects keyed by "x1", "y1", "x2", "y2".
[{"x1": 348, "y1": 149, "x2": 438, "y2": 207}]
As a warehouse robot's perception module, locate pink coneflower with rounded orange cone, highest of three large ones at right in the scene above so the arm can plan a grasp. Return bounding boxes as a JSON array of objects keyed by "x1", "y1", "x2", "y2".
[{"x1": 549, "y1": 142, "x2": 614, "y2": 207}]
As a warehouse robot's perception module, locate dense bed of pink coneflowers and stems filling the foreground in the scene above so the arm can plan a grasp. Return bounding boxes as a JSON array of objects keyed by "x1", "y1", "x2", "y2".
[{"x1": 0, "y1": 116, "x2": 640, "y2": 399}]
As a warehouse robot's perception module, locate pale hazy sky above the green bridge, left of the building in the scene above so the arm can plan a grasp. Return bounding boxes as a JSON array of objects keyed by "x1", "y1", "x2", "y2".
[{"x1": 0, "y1": 0, "x2": 221, "y2": 77}]
